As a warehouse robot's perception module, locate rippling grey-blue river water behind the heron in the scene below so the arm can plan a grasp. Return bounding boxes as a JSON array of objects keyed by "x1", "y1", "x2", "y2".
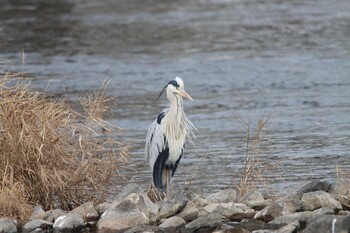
[{"x1": 0, "y1": 0, "x2": 350, "y2": 198}]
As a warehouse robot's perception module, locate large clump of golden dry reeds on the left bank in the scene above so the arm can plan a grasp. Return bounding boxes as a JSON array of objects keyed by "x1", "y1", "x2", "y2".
[{"x1": 0, "y1": 74, "x2": 126, "y2": 221}]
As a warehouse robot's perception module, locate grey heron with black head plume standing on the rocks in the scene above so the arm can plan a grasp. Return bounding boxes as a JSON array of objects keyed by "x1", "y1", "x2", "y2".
[{"x1": 145, "y1": 77, "x2": 196, "y2": 197}]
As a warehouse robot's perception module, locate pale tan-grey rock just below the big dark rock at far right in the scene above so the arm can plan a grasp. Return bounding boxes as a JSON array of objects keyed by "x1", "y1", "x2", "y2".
[{"x1": 301, "y1": 191, "x2": 342, "y2": 211}]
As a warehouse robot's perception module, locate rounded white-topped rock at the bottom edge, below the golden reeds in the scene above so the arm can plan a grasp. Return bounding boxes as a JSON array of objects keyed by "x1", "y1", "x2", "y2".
[{"x1": 53, "y1": 213, "x2": 84, "y2": 233}]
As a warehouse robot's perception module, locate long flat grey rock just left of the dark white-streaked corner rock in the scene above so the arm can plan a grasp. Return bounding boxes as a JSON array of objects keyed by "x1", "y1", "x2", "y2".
[{"x1": 267, "y1": 211, "x2": 316, "y2": 228}]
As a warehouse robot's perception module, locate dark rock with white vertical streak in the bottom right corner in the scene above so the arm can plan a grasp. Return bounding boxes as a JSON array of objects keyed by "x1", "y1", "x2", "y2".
[{"x1": 303, "y1": 215, "x2": 350, "y2": 233}]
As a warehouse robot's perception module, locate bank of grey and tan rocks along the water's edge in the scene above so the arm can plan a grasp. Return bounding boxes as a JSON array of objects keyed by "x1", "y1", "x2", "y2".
[{"x1": 0, "y1": 179, "x2": 350, "y2": 233}]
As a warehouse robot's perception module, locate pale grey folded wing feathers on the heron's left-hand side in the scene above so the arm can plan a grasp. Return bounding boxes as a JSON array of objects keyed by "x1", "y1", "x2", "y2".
[{"x1": 145, "y1": 109, "x2": 168, "y2": 171}]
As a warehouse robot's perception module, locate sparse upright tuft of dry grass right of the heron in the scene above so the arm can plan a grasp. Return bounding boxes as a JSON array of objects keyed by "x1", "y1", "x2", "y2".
[{"x1": 236, "y1": 116, "x2": 268, "y2": 195}]
